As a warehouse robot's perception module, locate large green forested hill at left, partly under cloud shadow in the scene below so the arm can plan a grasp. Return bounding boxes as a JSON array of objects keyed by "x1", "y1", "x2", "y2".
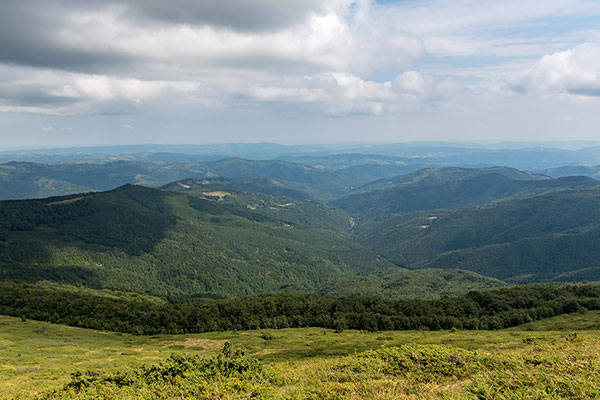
[{"x1": 0, "y1": 185, "x2": 395, "y2": 297}]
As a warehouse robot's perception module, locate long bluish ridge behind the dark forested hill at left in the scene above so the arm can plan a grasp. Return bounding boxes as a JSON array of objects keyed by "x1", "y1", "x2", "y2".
[{"x1": 0, "y1": 158, "x2": 412, "y2": 201}]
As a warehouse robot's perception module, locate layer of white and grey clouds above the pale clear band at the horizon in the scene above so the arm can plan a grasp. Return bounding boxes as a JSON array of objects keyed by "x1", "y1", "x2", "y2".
[{"x1": 0, "y1": 0, "x2": 600, "y2": 120}]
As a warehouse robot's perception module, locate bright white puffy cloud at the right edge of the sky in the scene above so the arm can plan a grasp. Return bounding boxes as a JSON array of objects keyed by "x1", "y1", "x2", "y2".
[{"x1": 508, "y1": 43, "x2": 600, "y2": 96}]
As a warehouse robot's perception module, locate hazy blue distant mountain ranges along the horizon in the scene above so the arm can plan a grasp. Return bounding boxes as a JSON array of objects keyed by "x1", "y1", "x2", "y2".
[{"x1": 0, "y1": 143, "x2": 600, "y2": 201}]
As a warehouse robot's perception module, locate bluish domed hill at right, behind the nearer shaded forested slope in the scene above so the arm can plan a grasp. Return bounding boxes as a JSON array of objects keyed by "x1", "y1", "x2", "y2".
[{"x1": 332, "y1": 167, "x2": 600, "y2": 218}]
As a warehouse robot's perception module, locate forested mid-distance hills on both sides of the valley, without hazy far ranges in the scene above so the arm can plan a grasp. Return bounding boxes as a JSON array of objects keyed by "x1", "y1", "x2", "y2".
[{"x1": 0, "y1": 169, "x2": 600, "y2": 298}]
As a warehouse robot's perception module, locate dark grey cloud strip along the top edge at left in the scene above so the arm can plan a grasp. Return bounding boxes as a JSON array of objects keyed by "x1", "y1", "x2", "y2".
[{"x1": 0, "y1": 0, "x2": 332, "y2": 31}]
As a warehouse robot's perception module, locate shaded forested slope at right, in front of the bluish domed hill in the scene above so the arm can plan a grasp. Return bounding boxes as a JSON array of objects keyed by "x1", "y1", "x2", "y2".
[{"x1": 357, "y1": 189, "x2": 600, "y2": 283}]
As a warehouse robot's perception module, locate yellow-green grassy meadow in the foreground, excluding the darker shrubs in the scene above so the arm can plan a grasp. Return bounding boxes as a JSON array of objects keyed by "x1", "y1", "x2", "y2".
[{"x1": 0, "y1": 312, "x2": 600, "y2": 399}]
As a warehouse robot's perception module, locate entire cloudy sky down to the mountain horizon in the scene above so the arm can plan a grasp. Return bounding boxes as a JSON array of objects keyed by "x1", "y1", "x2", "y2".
[{"x1": 0, "y1": 0, "x2": 600, "y2": 148}]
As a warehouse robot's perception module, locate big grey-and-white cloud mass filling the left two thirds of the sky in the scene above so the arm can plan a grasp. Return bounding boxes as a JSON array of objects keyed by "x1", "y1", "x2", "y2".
[{"x1": 0, "y1": 0, "x2": 423, "y2": 115}]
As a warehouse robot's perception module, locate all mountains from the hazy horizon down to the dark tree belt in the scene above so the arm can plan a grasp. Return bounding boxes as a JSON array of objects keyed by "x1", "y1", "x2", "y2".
[{"x1": 0, "y1": 144, "x2": 600, "y2": 298}]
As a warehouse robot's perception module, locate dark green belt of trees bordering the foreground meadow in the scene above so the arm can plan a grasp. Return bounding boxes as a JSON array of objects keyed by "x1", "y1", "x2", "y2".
[{"x1": 0, "y1": 282, "x2": 600, "y2": 334}]
